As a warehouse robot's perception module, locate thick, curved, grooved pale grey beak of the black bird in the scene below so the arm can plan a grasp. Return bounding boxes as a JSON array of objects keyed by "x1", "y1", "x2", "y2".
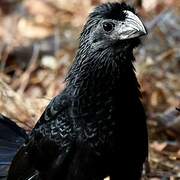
[{"x1": 118, "y1": 10, "x2": 147, "y2": 40}]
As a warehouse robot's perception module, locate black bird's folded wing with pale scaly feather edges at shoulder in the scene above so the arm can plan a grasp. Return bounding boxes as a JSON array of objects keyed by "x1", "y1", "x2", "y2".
[{"x1": 8, "y1": 93, "x2": 74, "y2": 180}]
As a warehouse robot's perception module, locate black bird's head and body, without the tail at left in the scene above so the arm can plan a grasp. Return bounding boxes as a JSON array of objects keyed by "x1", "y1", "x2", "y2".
[{"x1": 8, "y1": 3, "x2": 148, "y2": 180}]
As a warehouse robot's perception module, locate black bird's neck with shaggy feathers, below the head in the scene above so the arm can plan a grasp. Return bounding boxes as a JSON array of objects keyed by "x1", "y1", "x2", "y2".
[{"x1": 67, "y1": 49, "x2": 140, "y2": 104}]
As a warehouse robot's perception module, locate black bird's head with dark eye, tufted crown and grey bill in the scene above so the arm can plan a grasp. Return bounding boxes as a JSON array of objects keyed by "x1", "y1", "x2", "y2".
[{"x1": 80, "y1": 3, "x2": 147, "y2": 51}]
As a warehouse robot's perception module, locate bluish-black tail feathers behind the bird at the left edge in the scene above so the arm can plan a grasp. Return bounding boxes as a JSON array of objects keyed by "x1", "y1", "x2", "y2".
[{"x1": 0, "y1": 114, "x2": 28, "y2": 178}]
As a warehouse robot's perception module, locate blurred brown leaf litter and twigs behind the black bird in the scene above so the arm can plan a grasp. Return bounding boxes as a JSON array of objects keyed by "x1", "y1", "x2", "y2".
[{"x1": 0, "y1": 0, "x2": 180, "y2": 180}]
